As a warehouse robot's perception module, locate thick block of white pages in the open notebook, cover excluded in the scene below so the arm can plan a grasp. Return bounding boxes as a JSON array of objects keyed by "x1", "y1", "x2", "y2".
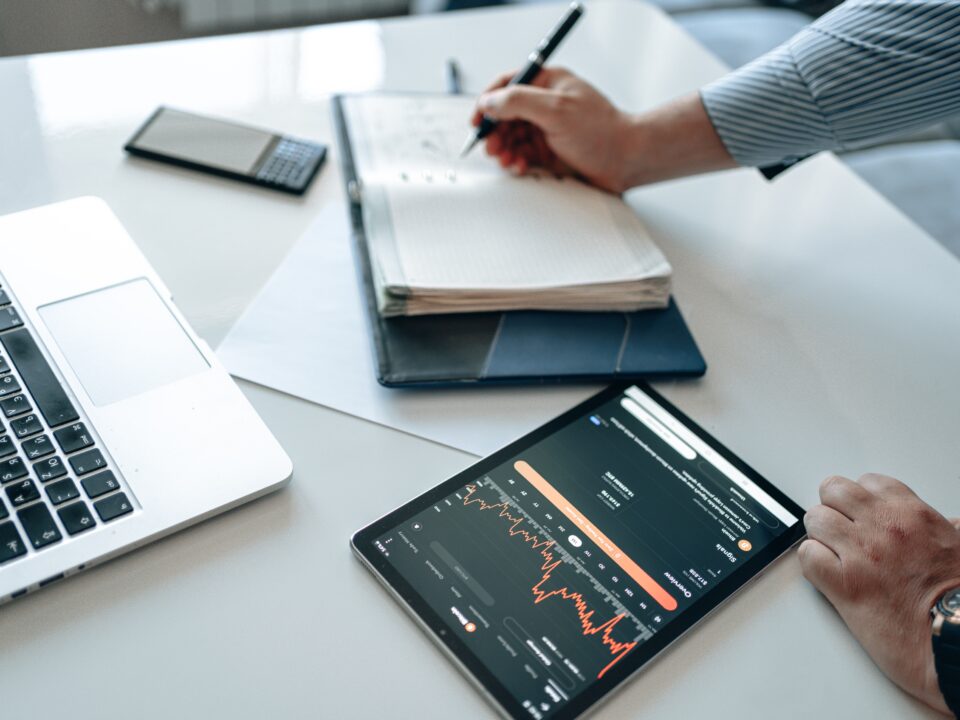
[{"x1": 341, "y1": 95, "x2": 671, "y2": 317}]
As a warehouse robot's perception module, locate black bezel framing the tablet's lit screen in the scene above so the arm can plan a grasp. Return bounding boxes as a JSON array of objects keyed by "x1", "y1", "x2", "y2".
[{"x1": 351, "y1": 382, "x2": 806, "y2": 720}]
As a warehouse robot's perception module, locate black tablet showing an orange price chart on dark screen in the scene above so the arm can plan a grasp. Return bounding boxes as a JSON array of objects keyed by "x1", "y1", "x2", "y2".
[{"x1": 352, "y1": 384, "x2": 804, "y2": 718}]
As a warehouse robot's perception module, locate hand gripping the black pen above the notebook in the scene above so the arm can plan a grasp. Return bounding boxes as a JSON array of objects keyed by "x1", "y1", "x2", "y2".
[{"x1": 472, "y1": 68, "x2": 631, "y2": 193}]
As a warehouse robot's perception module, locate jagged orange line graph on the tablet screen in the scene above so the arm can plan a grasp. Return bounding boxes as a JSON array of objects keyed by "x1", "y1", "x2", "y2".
[{"x1": 463, "y1": 485, "x2": 637, "y2": 679}]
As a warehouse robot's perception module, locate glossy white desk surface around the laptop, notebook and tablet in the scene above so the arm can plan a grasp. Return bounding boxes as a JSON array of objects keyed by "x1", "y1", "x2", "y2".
[{"x1": 0, "y1": 0, "x2": 960, "y2": 719}]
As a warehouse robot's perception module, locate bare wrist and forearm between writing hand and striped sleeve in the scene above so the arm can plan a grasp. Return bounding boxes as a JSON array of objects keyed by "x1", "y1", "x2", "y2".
[{"x1": 621, "y1": 93, "x2": 737, "y2": 188}]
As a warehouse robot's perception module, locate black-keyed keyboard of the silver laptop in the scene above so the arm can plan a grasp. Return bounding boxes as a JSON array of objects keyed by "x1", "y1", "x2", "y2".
[{"x1": 0, "y1": 286, "x2": 133, "y2": 567}]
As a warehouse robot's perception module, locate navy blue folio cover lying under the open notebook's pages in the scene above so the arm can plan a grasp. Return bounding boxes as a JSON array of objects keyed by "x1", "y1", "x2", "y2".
[{"x1": 333, "y1": 97, "x2": 707, "y2": 387}]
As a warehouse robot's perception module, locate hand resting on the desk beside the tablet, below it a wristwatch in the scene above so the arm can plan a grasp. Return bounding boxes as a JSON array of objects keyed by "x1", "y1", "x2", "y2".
[{"x1": 800, "y1": 474, "x2": 960, "y2": 714}]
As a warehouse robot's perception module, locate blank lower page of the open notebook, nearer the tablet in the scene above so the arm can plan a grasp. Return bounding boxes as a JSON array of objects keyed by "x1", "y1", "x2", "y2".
[{"x1": 387, "y1": 174, "x2": 663, "y2": 290}]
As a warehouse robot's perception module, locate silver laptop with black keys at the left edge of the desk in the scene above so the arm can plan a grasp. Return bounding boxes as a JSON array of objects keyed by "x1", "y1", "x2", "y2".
[{"x1": 0, "y1": 198, "x2": 292, "y2": 603}]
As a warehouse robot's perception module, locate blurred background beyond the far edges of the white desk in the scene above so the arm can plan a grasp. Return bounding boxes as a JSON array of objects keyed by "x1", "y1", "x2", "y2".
[{"x1": 0, "y1": 0, "x2": 960, "y2": 256}]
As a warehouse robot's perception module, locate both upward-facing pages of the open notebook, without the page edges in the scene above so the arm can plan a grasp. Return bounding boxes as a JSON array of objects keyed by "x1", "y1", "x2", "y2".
[{"x1": 346, "y1": 95, "x2": 670, "y2": 290}]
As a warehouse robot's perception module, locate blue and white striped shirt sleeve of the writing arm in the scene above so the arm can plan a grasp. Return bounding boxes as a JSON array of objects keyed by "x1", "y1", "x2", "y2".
[{"x1": 700, "y1": 0, "x2": 960, "y2": 167}]
